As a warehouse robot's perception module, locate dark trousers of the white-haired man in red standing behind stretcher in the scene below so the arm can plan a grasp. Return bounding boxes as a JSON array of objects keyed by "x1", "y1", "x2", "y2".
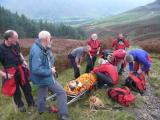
[{"x1": 86, "y1": 55, "x2": 97, "y2": 73}]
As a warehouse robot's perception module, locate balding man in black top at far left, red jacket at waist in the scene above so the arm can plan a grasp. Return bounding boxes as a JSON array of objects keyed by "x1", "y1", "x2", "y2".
[{"x1": 0, "y1": 30, "x2": 34, "y2": 112}]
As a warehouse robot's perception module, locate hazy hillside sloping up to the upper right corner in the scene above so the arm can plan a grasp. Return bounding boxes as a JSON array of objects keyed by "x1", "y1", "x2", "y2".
[{"x1": 84, "y1": 0, "x2": 160, "y2": 39}]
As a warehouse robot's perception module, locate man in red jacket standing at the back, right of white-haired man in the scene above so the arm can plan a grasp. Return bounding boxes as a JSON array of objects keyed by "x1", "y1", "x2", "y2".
[{"x1": 112, "y1": 33, "x2": 129, "y2": 50}]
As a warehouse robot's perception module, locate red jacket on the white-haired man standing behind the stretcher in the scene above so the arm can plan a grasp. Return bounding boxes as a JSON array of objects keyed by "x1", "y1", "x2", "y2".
[{"x1": 87, "y1": 39, "x2": 101, "y2": 56}]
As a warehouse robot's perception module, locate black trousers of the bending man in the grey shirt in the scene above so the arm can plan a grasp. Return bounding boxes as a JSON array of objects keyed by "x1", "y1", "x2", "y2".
[{"x1": 68, "y1": 54, "x2": 80, "y2": 78}]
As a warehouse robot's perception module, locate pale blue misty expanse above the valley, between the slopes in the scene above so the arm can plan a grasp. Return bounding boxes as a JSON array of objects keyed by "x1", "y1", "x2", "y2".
[{"x1": 0, "y1": 0, "x2": 153, "y2": 25}]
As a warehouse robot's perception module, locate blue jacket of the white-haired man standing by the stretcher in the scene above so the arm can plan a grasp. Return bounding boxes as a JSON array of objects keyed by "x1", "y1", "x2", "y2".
[{"x1": 29, "y1": 40, "x2": 55, "y2": 85}]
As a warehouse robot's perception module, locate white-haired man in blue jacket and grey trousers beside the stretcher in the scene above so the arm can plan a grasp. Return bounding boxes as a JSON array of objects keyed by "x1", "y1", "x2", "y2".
[{"x1": 29, "y1": 31, "x2": 70, "y2": 120}]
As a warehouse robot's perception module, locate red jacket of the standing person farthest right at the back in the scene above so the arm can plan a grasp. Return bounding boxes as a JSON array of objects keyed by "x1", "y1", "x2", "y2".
[{"x1": 112, "y1": 38, "x2": 129, "y2": 50}]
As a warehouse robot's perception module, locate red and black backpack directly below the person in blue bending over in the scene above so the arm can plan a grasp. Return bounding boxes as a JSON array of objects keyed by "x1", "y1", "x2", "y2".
[{"x1": 125, "y1": 72, "x2": 146, "y2": 94}]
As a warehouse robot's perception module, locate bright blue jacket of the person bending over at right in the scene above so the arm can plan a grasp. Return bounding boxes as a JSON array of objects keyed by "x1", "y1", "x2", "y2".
[{"x1": 129, "y1": 49, "x2": 151, "y2": 71}]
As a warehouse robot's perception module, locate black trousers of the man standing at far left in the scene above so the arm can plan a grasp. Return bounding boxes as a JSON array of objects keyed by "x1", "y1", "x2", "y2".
[{"x1": 13, "y1": 73, "x2": 35, "y2": 107}]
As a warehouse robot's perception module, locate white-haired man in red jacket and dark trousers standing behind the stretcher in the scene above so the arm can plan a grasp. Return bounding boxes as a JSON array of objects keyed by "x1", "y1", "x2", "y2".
[{"x1": 86, "y1": 33, "x2": 101, "y2": 73}]
